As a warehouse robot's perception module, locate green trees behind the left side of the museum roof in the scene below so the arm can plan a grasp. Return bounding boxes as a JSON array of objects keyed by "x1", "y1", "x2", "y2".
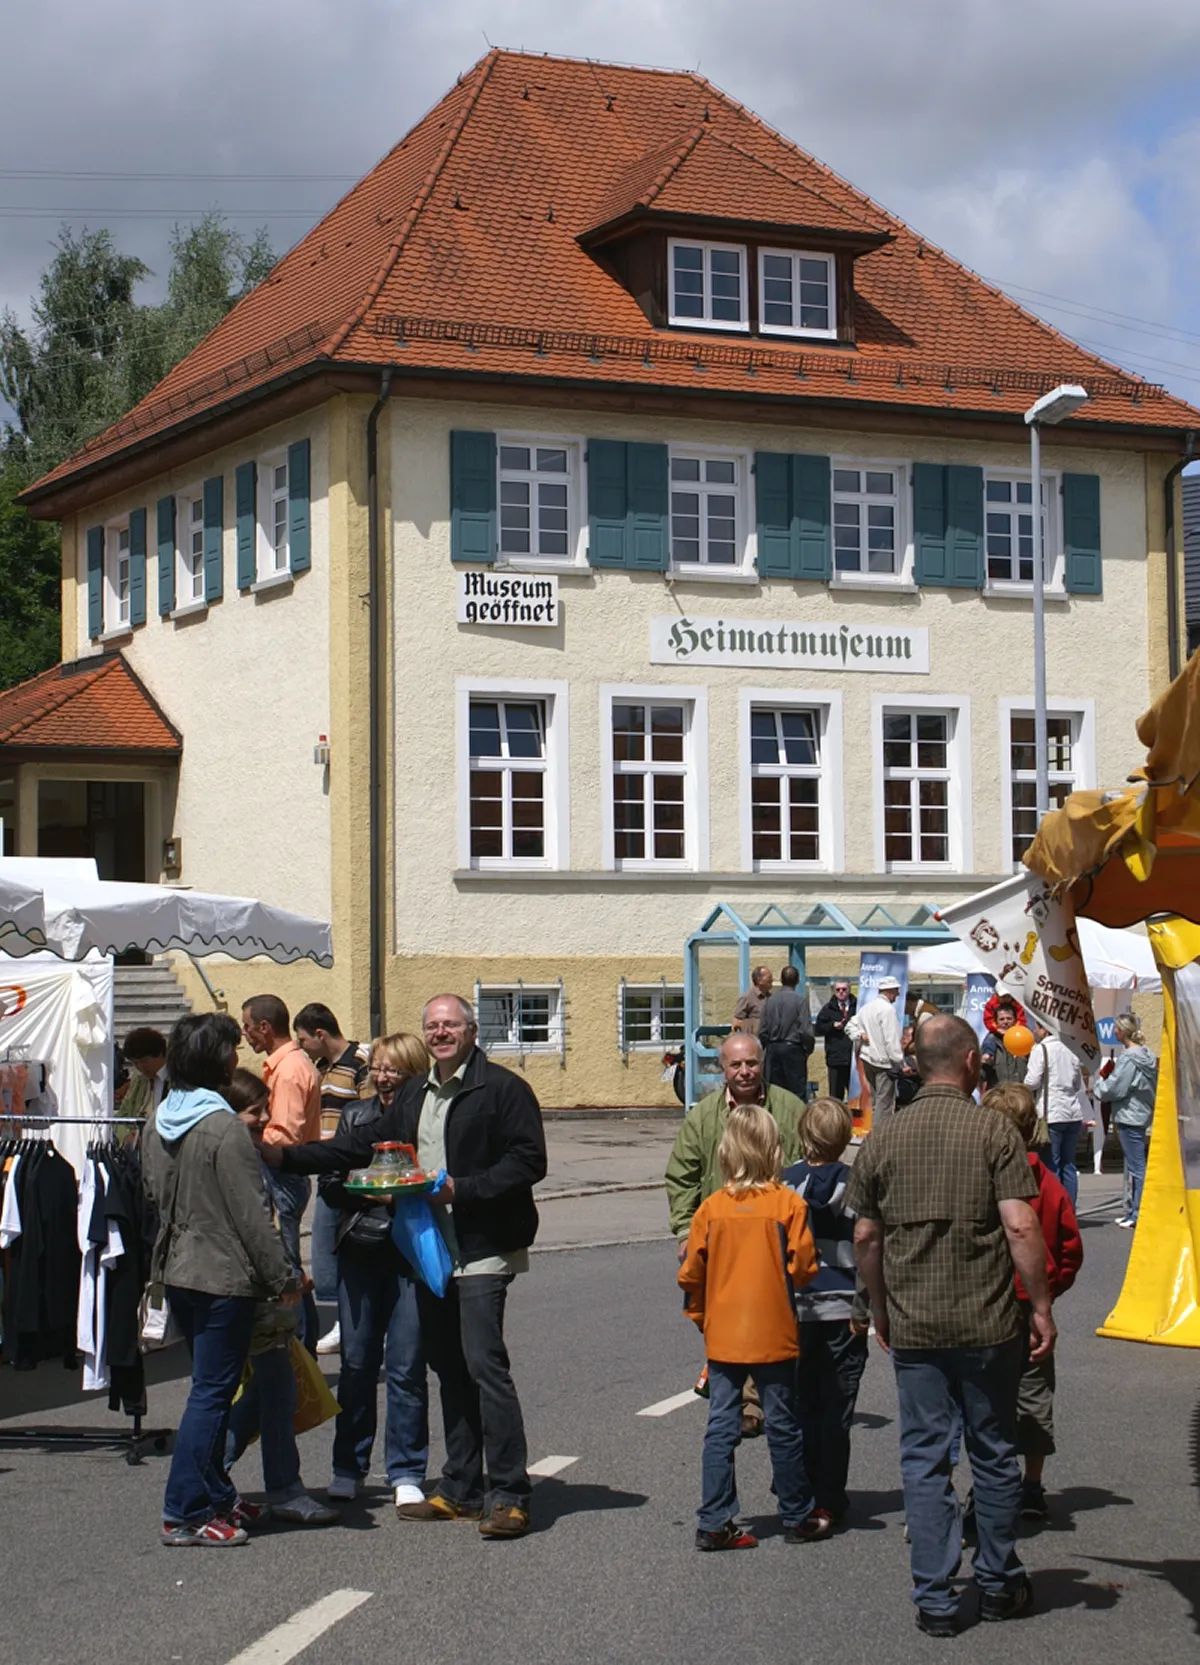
[{"x1": 0, "y1": 213, "x2": 275, "y2": 688}]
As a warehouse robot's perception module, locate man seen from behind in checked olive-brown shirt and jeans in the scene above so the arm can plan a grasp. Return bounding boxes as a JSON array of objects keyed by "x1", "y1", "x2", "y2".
[{"x1": 845, "y1": 1017, "x2": 1055, "y2": 1637}]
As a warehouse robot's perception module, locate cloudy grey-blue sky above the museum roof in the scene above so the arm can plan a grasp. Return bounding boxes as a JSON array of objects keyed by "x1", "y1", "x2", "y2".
[{"x1": 0, "y1": 0, "x2": 1200, "y2": 426}]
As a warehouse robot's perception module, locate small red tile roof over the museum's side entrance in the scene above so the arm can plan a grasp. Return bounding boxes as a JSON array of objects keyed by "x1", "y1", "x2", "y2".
[{"x1": 0, "y1": 653, "x2": 183, "y2": 763}]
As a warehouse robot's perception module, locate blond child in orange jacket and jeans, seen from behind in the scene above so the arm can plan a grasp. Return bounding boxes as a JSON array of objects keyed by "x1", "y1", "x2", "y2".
[{"x1": 679, "y1": 1104, "x2": 827, "y2": 1550}]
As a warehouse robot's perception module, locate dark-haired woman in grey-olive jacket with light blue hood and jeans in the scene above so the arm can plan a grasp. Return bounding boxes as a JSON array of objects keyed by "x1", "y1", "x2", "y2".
[{"x1": 141, "y1": 1012, "x2": 300, "y2": 1548}]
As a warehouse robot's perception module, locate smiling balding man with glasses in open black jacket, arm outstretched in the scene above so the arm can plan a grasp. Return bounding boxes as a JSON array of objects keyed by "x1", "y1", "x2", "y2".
[{"x1": 271, "y1": 994, "x2": 546, "y2": 1538}]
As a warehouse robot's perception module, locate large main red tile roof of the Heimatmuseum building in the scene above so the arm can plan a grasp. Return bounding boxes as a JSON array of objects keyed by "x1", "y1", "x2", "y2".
[{"x1": 32, "y1": 52, "x2": 1200, "y2": 500}]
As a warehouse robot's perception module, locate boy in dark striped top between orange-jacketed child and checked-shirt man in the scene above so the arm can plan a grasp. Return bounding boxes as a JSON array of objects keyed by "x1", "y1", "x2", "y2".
[{"x1": 784, "y1": 1099, "x2": 869, "y2": 1530}]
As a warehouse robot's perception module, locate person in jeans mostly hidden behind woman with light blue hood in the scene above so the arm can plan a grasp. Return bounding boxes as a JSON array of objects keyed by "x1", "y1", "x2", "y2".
[{"x1": 221, "y1": 1069, "x2": 338, "y2": 1527}]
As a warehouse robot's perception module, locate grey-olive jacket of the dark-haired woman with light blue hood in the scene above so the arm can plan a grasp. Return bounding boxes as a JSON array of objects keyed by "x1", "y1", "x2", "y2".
[{"x1": 141, "y1": 1111, "x2": 291, "y2": 1300}]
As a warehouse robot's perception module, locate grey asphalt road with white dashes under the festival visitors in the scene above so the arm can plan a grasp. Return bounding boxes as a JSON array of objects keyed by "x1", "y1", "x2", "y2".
[{"x1": 0, "y1": 1182, "x2": 1200, "y2": 1665}]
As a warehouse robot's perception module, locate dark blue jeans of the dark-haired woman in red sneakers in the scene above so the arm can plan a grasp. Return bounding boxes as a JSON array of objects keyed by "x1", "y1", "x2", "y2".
[{"x1": 163, "y1": 1289, "x2": 255, "y2": 1527}]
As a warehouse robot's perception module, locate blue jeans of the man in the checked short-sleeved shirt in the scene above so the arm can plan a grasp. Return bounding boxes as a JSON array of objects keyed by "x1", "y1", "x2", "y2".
[{"x1": 892, "y1": 1335, "x2": 1025, "y2": 1613}]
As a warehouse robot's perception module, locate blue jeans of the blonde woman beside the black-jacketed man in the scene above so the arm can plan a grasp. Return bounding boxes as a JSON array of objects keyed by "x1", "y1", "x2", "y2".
[{"x1": 333, "y1": 1244, "x2": 429, "y2": 1485}]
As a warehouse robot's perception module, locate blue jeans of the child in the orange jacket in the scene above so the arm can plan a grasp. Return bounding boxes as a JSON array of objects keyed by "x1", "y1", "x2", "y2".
[{"x1": 696, "y1": 1359, "x2": 812, "y2": 1532}]
